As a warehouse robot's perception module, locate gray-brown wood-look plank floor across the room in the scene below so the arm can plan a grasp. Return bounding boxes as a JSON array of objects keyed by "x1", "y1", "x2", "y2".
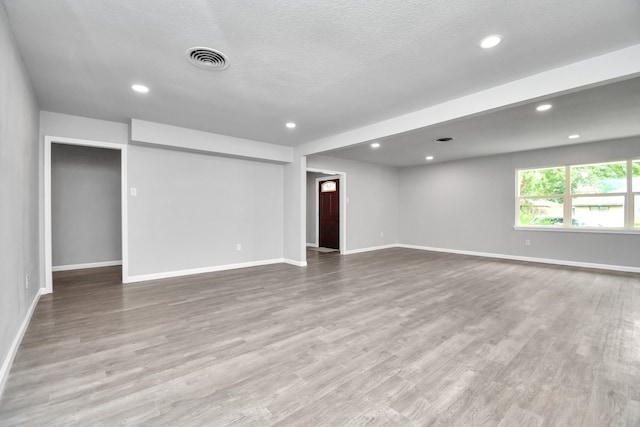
[{"x1": 0, "y1": 249, "x2": 640, "y2": 426}]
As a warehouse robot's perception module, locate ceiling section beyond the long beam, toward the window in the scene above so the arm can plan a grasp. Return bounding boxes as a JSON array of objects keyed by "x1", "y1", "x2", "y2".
[{"x1": 324, "y1": 77, "x2": 640, "y2": 167}]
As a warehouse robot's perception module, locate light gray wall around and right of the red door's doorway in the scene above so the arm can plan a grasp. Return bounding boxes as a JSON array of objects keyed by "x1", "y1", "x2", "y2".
[{"x1": 307, "y1": 155, "x2": 398, "y2": 251}]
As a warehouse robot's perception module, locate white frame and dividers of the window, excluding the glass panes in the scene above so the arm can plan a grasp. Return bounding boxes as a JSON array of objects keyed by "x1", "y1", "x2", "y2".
[{"x1": 513, "y1": 159, "x2": 640, "y2": 234}]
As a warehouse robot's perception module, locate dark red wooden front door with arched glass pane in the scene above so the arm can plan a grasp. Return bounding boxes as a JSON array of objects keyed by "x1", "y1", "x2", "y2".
[{"x1": 318, "y1": 179, "x2": 340, "y2": 249}]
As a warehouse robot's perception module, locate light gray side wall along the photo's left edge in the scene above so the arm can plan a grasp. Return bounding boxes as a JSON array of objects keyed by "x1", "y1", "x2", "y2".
[{"x1": 0, "y1": 3, "x2": 41, "y2": 390}]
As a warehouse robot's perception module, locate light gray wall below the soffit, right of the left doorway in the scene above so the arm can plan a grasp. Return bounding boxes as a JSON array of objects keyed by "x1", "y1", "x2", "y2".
[{"x1": 128, "y1": 145, "x2": 283, "y2": 276}]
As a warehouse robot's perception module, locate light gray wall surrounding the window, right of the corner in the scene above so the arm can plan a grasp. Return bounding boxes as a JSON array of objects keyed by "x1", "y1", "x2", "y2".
[{"x1": 400, "y1": 138, "x2": 640, "y2": 267}]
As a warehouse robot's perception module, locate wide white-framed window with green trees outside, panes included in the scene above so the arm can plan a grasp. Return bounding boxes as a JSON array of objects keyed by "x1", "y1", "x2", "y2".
[{"x1": 516, "y1": 160, "x2": 640, "y2": 229}]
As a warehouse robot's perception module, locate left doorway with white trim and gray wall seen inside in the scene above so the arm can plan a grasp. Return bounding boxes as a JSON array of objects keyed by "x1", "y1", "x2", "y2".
[{"x1": 43, "y1": 136, "x2": 128, "y2": 293}]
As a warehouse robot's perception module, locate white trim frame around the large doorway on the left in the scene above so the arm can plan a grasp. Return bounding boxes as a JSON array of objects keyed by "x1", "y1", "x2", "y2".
[{"x1": 43, "y1": 135, "x2": 129, "y2": 294}]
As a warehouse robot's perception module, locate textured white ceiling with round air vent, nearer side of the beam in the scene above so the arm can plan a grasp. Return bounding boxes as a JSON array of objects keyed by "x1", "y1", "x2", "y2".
[{"x1": 4, "y1": 0, "x2": 640, "y2": 152}]
